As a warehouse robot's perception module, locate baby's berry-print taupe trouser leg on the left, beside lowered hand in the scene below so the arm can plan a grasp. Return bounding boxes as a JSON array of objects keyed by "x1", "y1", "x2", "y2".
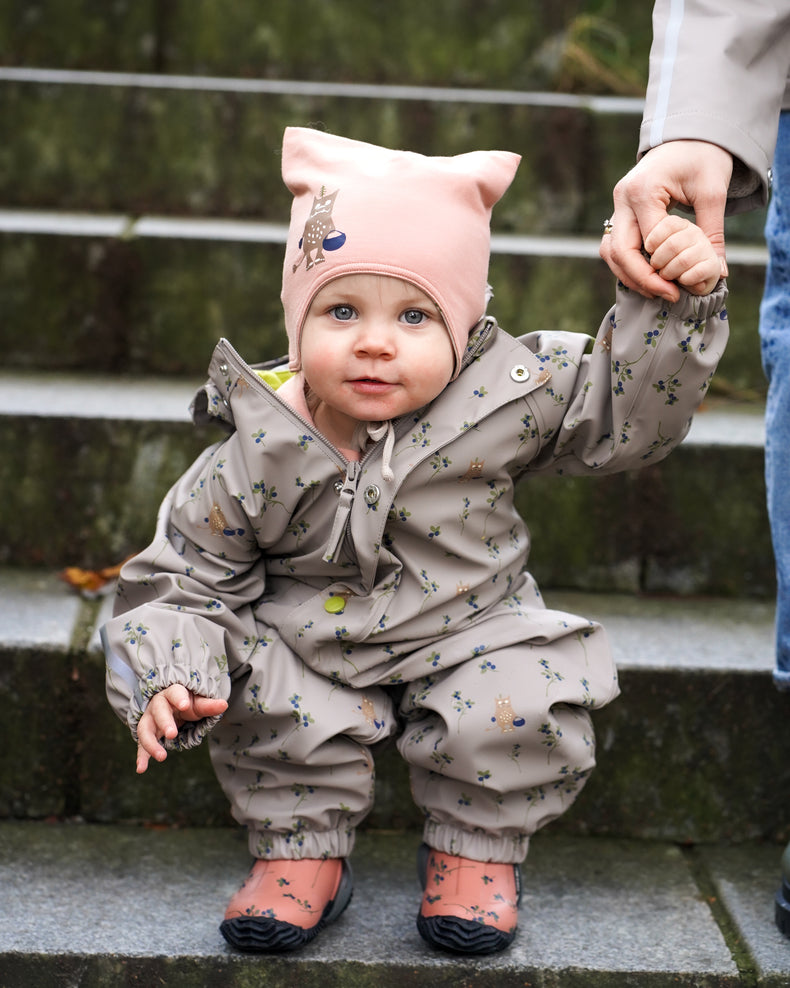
[{"x1": 210, "y1": 642, "x2": 395, "y2": 858}]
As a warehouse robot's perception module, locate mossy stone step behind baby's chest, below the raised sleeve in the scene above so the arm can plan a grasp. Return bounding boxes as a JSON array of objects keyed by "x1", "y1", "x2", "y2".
[{"x1": 0, "y1": 370, "x2": 775, "y2": 597}]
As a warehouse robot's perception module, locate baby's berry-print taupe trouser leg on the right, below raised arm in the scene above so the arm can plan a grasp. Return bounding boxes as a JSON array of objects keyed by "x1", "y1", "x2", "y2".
[{"x1": 398, "y1": 626, "x2": 617, "y2": 863}]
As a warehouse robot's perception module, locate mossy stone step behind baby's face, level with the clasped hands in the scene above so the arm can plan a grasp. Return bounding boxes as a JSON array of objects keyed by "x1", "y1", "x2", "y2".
[{"x1": 0, "y1": 210, "x2": 767, "y2": 396}]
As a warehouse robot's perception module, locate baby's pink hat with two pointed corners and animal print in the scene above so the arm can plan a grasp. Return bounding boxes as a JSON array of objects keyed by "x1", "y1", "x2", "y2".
[{"x1": 281, "y1": 127, "x2": 521, "y2": 374}]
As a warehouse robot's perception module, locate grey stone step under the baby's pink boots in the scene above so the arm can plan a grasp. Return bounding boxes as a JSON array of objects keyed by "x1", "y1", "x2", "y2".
[{"x1": 0, "y1": 822, "x2": 790, "y2": 988}]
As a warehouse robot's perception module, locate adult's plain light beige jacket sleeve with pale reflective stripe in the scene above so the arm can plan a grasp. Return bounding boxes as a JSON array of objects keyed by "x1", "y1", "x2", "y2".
[{"x1": 639, "y1": 0, "x2": 790, "y2": 213}]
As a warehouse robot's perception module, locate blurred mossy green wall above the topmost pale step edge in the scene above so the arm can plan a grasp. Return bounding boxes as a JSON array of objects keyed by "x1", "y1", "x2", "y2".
[{"x1": 0, "y1": 0, "x2": 651, "y2": 94}]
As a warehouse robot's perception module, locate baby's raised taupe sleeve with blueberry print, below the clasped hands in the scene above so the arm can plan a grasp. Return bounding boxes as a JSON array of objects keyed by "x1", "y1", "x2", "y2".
[{"x1": 528, "y1": 281, "x2": 729, "y2": 475}]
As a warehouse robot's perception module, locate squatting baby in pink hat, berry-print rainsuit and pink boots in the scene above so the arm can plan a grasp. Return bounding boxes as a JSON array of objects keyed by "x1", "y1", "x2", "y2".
[{"x1": 103, "y1": 128, "x2": 727, "y2": 954}]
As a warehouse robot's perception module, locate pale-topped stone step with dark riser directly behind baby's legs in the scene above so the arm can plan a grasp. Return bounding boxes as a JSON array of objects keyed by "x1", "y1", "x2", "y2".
[{"x1": 0, "y1": 570, "x2": 790, "y2": 842}]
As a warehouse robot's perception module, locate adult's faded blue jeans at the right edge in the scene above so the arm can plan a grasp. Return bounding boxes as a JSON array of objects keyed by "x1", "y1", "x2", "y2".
[{"x1": 760, "y1": 112, "x2": 790, "y2": 690}]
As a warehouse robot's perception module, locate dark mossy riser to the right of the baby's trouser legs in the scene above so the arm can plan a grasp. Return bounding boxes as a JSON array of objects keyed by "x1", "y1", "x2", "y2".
[{"x1": 552, "y1": 672, "x2": 790, "y2": 844}]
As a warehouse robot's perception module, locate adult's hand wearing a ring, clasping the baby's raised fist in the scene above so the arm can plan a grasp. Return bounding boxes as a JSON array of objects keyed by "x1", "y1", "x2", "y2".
[{"x1": 599, "y1": 141, "x2": 732, "y2": 302}]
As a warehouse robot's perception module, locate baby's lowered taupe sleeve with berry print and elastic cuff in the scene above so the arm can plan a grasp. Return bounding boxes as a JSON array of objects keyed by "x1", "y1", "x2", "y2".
[{"x1": 101, "y1": 435, "x2": 265, "y2": 748}]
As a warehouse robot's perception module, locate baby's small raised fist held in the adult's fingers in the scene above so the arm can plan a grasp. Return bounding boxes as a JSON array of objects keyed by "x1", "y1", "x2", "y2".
[{"x1": 645, "y1": 216, "x2": 723, "y2": 295}]
